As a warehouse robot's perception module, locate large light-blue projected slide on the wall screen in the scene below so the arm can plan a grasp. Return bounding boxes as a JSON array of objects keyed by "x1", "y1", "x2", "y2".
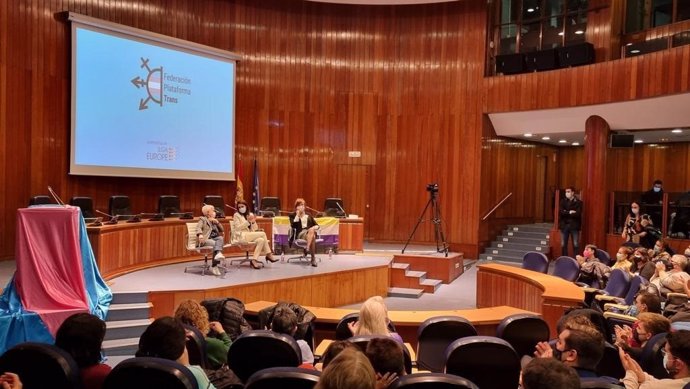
[{"x1": 70, "y1": 25, "x2": 235, "y2": 180}]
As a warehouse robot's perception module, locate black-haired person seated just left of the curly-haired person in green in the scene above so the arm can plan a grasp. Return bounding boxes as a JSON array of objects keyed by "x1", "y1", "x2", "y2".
[{"x1": 136, "y1": 316, "x2": 216, "y2": 389}]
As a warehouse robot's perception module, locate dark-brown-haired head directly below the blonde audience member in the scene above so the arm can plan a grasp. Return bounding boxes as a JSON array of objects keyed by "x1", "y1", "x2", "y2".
[{"x1": 365, "y1": 337, "x2": 405, "y2": 388}]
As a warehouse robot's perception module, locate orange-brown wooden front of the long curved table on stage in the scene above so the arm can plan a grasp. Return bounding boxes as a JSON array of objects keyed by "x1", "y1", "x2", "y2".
[{"x1": 87, "y1": 217, "x2": 364, "y2": 279}]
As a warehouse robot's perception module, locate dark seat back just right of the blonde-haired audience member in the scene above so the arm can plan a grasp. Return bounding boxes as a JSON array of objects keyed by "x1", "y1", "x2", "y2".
[{"x1": 417, "y1": 316, "x2": 477, "y2": 373}]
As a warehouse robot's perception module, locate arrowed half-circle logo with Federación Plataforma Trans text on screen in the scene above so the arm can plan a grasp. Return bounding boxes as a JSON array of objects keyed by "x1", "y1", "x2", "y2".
[{"x1": 131, "y1": 57, "x2": 192, "y2": 111}]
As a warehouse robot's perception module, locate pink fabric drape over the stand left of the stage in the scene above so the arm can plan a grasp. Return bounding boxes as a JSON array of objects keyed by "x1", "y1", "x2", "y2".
[{"x1": 15, "y1": 207, "x2": 89, "y2": 336}]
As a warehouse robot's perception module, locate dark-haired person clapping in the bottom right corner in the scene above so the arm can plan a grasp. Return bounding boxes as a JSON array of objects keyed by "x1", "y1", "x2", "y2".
[{"x1": 619, "y1": 330, "x2": 690, "y2": 389}]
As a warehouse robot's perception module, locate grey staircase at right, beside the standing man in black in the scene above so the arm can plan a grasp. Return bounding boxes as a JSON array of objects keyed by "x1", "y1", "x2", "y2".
[{"x1": 479, "y1": 223, "x2": 553, "y2": 263}]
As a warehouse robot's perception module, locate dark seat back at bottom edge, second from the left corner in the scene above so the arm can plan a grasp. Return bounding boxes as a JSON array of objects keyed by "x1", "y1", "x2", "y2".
[{"x1": 103, "y1": 357, "x2": 198, "y2": 389}]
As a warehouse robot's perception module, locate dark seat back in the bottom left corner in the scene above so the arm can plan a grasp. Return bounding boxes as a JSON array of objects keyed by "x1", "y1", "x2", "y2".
[{"x1": 0, "y1": 342, "x2": 81, "y2": 389}]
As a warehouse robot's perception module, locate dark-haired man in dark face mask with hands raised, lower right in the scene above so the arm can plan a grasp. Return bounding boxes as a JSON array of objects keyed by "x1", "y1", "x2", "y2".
[{"x1": 534, "y1": 324, "x2": 604, "y2": 378}]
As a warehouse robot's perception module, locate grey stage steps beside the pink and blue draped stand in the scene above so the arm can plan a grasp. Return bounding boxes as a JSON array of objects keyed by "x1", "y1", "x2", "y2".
[{"x1": 103, "y1": 292, "x2": 153, "y2": 357}]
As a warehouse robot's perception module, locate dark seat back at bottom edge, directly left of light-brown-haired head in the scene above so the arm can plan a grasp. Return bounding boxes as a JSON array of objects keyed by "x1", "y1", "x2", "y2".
[{"x1": 244, "y1": 367, "x2": 321, "y2": 389}]
